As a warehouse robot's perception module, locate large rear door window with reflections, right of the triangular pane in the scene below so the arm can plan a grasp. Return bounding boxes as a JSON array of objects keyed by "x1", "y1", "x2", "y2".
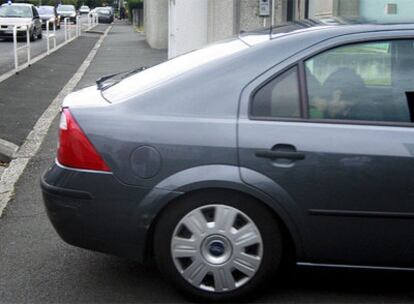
[{"x1": 305, "y1": 40, "x2": 414, "y2": 122}]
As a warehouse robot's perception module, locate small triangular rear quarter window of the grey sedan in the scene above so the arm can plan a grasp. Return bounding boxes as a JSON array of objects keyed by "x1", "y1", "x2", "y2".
[{"x1": 251, "y1": 66, "x2": 300, "y2": 118}]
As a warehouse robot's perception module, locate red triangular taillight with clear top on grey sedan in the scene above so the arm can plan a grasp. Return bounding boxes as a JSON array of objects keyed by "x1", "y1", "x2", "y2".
[{"x1": 57, "y1": 109, "x2": 110, "y2": 172}]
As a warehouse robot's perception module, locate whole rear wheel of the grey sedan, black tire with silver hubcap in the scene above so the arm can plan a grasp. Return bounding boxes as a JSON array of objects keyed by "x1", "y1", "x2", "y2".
[{"x1": 153, "y1": 190, "x2": 283, "y2": 301}]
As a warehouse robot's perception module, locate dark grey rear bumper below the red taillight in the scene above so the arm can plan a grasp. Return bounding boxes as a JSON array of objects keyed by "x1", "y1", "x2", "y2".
[{"x1": 41, "y1": 165, "x2": 179, "y2": 262}]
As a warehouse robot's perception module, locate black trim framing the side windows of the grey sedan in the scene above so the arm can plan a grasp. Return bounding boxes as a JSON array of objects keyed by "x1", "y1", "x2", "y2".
[{"x1": 247, "y1": 34, "x2": 414, "y2": 128}]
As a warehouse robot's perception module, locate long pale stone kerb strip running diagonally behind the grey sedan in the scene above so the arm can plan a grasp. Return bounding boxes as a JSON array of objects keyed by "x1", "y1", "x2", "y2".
[{"x1": 0, "y1": 26, "x2": 112, "y2": 217}]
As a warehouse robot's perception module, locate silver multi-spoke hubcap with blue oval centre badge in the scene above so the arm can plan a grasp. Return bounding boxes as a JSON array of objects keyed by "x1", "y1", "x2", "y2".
[{"x1": 171, "y1": 205, "x2": 263, "y2": 292}]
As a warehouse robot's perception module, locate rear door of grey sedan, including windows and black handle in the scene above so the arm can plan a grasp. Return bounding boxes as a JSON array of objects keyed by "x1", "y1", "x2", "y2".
[{"x1": 238, "y1": 38, "x2": 414, "y2": 267}]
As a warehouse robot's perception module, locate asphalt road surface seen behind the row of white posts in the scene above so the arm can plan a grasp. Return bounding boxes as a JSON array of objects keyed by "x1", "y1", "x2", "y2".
[{"x1": 0, "y1": 15, "x2": 88, "y2": 75}]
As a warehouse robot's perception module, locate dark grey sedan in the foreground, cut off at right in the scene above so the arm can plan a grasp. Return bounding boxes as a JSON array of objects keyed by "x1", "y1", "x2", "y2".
[{"x1": 41, "y1": 21, "x2": 414, "y2": 300}]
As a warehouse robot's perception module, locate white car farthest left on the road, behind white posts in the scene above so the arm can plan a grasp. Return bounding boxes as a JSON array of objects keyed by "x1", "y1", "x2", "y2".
[{"x1": 0, "y1": 3, "x2": 42, "y2": 41}]
